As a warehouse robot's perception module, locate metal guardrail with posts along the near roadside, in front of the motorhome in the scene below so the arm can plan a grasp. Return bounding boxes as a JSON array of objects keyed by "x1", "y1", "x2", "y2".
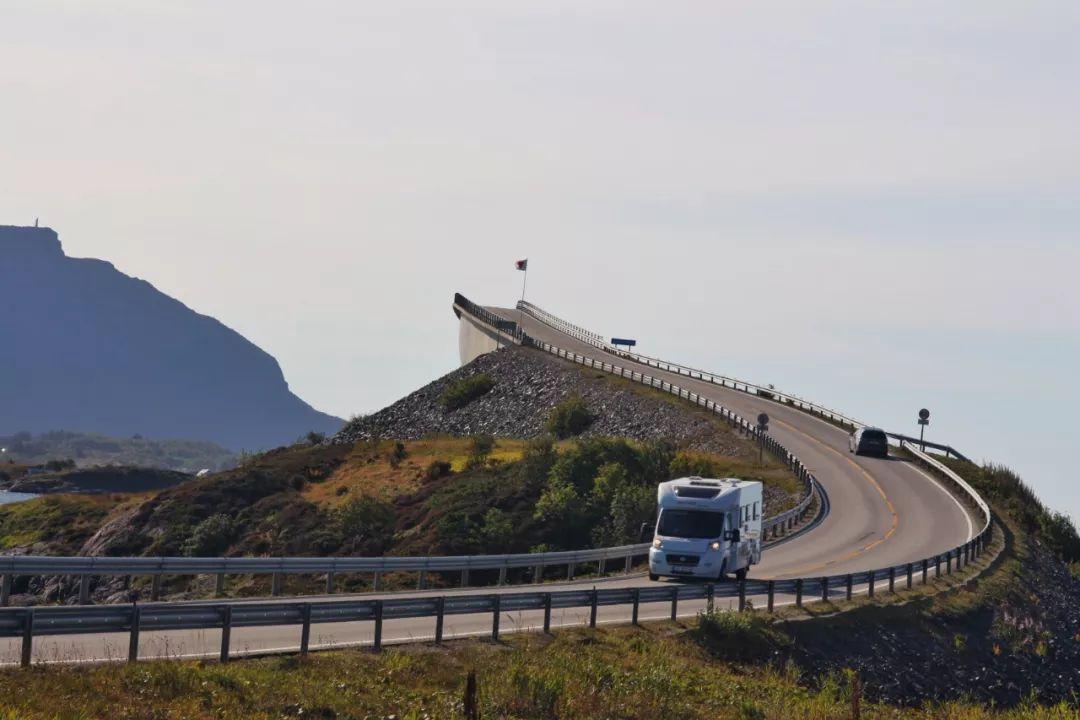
[{"x1": 0, "y1": 533, "x2": 989, "y2": 666}]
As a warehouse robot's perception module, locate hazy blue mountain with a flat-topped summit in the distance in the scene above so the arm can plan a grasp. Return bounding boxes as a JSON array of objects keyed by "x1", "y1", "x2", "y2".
[{"x1": 0, "y1": 226, "x2": 342, "y2": 450}]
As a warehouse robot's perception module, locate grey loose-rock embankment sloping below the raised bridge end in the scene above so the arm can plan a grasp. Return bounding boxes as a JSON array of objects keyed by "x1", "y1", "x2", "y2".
[{"x1": 334, "y1": 348, "x2": 746, "y2": 456}]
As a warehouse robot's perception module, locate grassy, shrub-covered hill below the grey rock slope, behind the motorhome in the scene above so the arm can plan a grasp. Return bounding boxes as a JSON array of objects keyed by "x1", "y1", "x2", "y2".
[{"x1": 0, "y1": 436, "x2": 800, "y2": 600}]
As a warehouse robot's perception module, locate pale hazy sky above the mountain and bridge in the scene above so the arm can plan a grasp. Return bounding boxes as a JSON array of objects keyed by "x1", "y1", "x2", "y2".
[{"x1": 0, "y1": 0, "x2": 1080, "y2": 518}]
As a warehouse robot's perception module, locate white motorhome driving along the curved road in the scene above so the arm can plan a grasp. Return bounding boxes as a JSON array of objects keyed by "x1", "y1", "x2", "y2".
[{"x1": 649, "y1": 477, "x2": 765, "y2": 580}]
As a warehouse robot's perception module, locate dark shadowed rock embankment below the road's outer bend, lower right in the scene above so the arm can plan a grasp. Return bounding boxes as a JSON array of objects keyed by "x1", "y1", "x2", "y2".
[{"x1": 787, "y1": 545, "x2": 1080, "y2": 706}]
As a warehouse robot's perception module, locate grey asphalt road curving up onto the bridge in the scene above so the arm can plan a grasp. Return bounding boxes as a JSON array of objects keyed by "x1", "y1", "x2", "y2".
[{"x1": 0, "y1": 308, "x2": 977, "y2": 663}]
